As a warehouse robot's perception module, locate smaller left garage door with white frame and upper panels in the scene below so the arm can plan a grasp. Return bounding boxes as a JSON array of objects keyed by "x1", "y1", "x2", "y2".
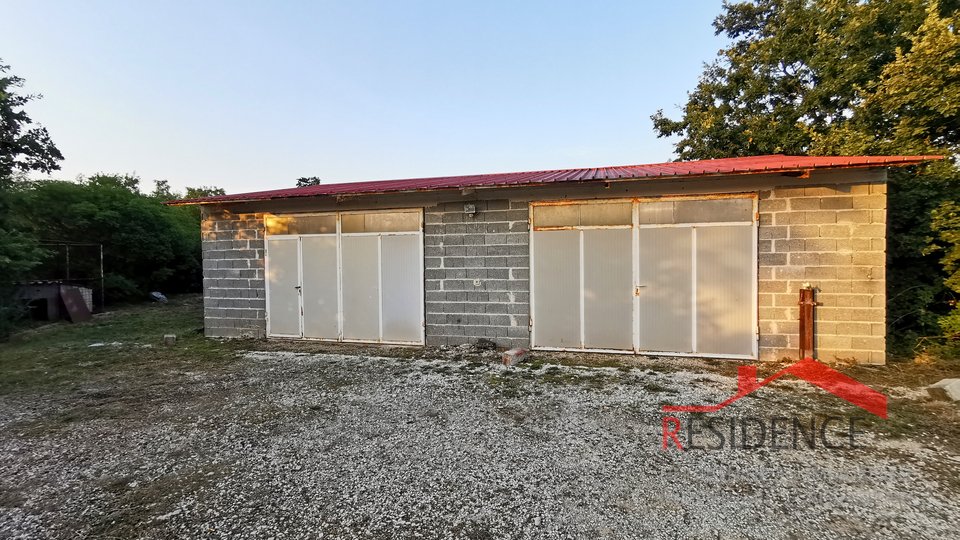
[{"x1": 266, "y1": 210, "x2": 424, "y2": 344}]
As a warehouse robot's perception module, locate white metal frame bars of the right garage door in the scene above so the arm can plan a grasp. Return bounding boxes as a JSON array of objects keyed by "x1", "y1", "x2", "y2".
[{"x1": 528, "y1": 193, "x2": 760, "y2": 360}]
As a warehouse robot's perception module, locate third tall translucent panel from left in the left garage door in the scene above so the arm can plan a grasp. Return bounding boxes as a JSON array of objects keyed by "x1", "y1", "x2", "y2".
[{"x1": 340, "y1": 234, "x2": 380, "y2": 341}]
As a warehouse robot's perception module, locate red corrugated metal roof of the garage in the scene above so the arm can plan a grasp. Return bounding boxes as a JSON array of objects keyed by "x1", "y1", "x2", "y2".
[{"x1": 168, "y1": 154, "x2": 943, "y2": 204}]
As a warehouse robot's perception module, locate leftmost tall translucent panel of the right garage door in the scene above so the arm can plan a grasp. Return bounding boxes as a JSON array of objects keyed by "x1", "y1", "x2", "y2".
[{"x1": 532, "y1": 231, "x2": 581, "y2": 348}]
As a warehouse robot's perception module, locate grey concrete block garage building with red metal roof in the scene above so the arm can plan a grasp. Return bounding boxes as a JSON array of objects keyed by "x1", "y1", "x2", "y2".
[{"x1": 171, "y1": 155, "x2": 932, "y2": 364}]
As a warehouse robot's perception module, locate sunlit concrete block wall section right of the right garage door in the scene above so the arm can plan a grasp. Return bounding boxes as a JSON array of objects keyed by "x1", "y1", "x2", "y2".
[{"x1": 758, "y1": 183, "x2": 887, "y2": 364}]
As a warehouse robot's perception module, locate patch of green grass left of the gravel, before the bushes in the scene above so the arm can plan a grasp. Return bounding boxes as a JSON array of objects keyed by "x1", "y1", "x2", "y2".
[{"x1": 0, "y1": 295, "x2": 249, "y2": 394}]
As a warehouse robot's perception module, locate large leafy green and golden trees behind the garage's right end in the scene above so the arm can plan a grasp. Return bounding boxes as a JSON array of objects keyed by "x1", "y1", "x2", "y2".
[{"x1": 652, "y1": 0, "x2": 960, "y2": 347}]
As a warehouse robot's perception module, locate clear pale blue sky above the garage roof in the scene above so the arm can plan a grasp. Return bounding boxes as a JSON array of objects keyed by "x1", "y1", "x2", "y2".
[{"x1": 0, "y1": 0, "x2": 723, "y2": 193}]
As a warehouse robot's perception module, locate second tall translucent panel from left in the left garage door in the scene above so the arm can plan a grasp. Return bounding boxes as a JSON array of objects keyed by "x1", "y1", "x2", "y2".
[{"x1": 300, "y1": 235, "x2": 339, "y2": 339}]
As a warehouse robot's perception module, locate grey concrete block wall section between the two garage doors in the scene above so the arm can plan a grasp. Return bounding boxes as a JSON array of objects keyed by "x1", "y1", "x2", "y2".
[{"x1": 424, "y1": 200, "x2": 530, "y2": 347}]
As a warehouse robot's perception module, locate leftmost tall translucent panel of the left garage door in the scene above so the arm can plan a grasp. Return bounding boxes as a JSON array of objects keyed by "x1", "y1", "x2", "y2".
[{"x1": 267, "y1": 238, "x2": 300, "y2": 337}]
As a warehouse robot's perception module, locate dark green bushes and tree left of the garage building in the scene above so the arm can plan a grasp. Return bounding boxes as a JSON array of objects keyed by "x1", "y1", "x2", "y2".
[{"x1": 0, "y1": 62, "x2": 224, "y2": 339}]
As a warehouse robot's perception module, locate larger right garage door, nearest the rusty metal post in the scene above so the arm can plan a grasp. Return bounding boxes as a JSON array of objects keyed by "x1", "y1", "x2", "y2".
[{"x1": 531, "y1": 197, "x2": 757, "y2": 358}]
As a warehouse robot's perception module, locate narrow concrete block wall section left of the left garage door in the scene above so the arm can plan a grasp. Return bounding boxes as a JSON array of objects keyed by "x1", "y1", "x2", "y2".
[{"x1": 200, "y1": 207, "x2": 267, "y2": 338}]
